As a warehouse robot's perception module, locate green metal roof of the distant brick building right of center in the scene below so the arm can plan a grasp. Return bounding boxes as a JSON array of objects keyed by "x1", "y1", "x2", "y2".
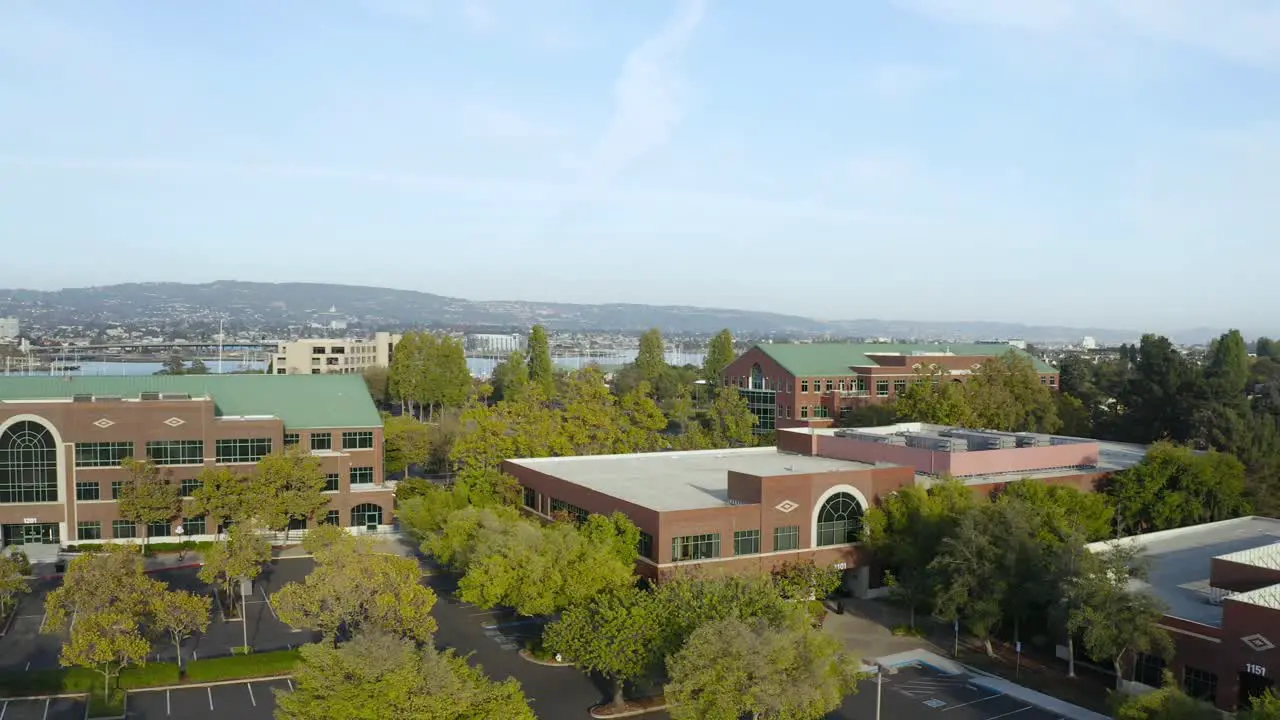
[{"x1": 756, "y1": 342, "x2": 1057, "y2": 377}]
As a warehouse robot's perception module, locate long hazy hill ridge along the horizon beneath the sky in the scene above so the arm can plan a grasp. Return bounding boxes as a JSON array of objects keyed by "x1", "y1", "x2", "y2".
[{"x1": 0, "y1": 281, "x2": 1198, "y2": 342}]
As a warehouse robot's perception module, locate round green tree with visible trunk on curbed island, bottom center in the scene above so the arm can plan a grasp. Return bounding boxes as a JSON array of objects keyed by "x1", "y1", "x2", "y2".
[{"x1": 543, "y1": 587, "x2": 662, "y2": 708}]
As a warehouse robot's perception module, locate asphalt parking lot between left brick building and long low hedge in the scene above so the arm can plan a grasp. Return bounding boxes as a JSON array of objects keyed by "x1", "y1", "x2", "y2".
[{"x1": 0, "y1": 559, "x2": 317, "y2": 670}]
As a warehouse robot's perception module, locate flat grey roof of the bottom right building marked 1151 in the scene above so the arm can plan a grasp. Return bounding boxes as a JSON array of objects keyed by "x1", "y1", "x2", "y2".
[{"x1": 1089, "y1": 516, "x2": 1280, "y2": 626}]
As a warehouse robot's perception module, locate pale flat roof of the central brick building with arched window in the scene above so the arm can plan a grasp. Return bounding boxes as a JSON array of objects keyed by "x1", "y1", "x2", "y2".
[{"x1": 508, "y1": 447, "x2": 876, "y2": 512}]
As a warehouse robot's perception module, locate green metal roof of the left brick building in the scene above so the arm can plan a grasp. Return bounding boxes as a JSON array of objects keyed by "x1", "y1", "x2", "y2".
[{"x1": 0, "y1": 374, "x2": 383, "y2": 428}]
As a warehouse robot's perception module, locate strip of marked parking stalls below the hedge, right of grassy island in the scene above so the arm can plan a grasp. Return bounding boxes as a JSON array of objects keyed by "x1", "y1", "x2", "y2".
[{"x1": 125, "y1": 680, "x2": 293, "y2": 720}]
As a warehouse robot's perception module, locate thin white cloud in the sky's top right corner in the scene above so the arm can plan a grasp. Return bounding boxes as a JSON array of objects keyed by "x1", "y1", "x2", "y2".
[{"x1": 896, "y1": 0, "x2": 1280, "y2": 65}]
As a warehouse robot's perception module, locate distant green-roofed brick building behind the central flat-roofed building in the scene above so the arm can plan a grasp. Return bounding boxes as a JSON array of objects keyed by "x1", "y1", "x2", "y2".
[{"x1": 724, "y1": 342, "x2": 1059, "y2": 434}]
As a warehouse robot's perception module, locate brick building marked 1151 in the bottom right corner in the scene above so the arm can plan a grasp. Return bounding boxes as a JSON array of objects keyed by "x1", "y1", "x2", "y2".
[{"x1": 1095, "y1": 518, "x2": 1280, "y2": 711}]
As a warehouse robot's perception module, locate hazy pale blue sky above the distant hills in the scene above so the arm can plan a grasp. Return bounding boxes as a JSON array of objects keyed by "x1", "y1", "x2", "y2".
[{"x1": 0, "y1": 0, "x2": 1280, "y2": 332}]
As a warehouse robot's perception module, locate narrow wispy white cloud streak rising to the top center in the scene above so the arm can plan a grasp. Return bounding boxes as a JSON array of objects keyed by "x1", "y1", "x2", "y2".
[{"x1": 586, "y1": 0, "x2": 707, "y2": 186}]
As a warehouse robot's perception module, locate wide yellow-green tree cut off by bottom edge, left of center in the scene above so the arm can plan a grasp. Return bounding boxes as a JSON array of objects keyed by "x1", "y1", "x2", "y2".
[{"x1": 275, "y1": 633, "x2": 534, "y2": 720}]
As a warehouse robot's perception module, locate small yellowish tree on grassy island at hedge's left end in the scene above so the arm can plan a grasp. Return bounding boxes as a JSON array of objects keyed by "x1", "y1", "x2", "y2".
[{"x1": 58, "y1": 609, "x2": 151, "y2": 700}]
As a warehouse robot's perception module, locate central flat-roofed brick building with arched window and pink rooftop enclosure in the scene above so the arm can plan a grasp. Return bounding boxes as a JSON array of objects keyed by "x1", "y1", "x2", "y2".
[{"x1": 503, "y1": 423, "x2": 1146, "y2": 586}]
